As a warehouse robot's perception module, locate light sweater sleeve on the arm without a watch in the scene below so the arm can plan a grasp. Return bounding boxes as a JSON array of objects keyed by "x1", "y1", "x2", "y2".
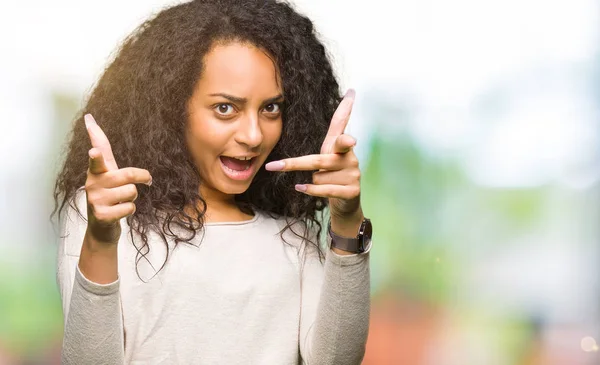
[{"x1": 57, "y1": 191, "x2": 124, "y2": 365}]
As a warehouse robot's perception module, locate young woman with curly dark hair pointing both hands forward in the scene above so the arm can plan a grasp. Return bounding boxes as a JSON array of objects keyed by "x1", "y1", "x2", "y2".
[{"x1": 55, "y1": 0, "x2": 371, "y2": 365}]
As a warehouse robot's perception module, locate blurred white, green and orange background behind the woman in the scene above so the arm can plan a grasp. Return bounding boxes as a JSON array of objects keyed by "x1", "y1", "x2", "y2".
[{"x1": 0, "y1": 0, "x2": 600, "y2": 365}]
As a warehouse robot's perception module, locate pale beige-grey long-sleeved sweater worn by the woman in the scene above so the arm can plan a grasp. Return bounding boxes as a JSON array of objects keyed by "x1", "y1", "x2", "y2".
[{"x1": 57, "y1": 194, "x2": 370, "y2": 365}]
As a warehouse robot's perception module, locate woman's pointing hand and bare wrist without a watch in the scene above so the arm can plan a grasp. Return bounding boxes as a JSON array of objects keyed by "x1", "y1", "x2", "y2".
[{"x1": 84, "y1": 114, "x2": 152, "y2": 245}]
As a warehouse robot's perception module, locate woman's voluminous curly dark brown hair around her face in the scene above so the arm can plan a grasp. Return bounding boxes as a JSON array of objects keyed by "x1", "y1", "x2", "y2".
[{"x1": 54, "y1": 0, "x2": 341, "y2": 271}]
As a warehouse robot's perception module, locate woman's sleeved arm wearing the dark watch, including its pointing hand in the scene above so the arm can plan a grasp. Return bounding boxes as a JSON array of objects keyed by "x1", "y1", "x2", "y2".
[{"x1": 265, "y1": 90, "x2": 370, "y2": 365}]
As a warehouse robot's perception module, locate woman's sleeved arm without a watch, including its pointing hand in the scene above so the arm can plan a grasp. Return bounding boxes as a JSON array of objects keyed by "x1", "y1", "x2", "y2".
[{"x1": 58, "y1": 114, "x2": 152, "y2": 365}]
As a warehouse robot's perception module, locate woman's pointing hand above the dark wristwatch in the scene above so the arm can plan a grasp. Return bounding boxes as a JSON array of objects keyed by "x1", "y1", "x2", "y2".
[{"x1": 265, "y1": 89, "x2": 364, "y2": 243}]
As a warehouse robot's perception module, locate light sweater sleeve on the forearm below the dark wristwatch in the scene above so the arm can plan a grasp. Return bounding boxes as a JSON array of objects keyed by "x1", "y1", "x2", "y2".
[{"x1": 300, "y1": 233, "x2": 370, "y2": 365}]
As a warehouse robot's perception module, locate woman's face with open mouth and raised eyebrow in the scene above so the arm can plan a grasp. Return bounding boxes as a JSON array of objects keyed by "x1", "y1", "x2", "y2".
[{"x1": 186, "y1": 42, "x2": 283, "y2": 199}]
